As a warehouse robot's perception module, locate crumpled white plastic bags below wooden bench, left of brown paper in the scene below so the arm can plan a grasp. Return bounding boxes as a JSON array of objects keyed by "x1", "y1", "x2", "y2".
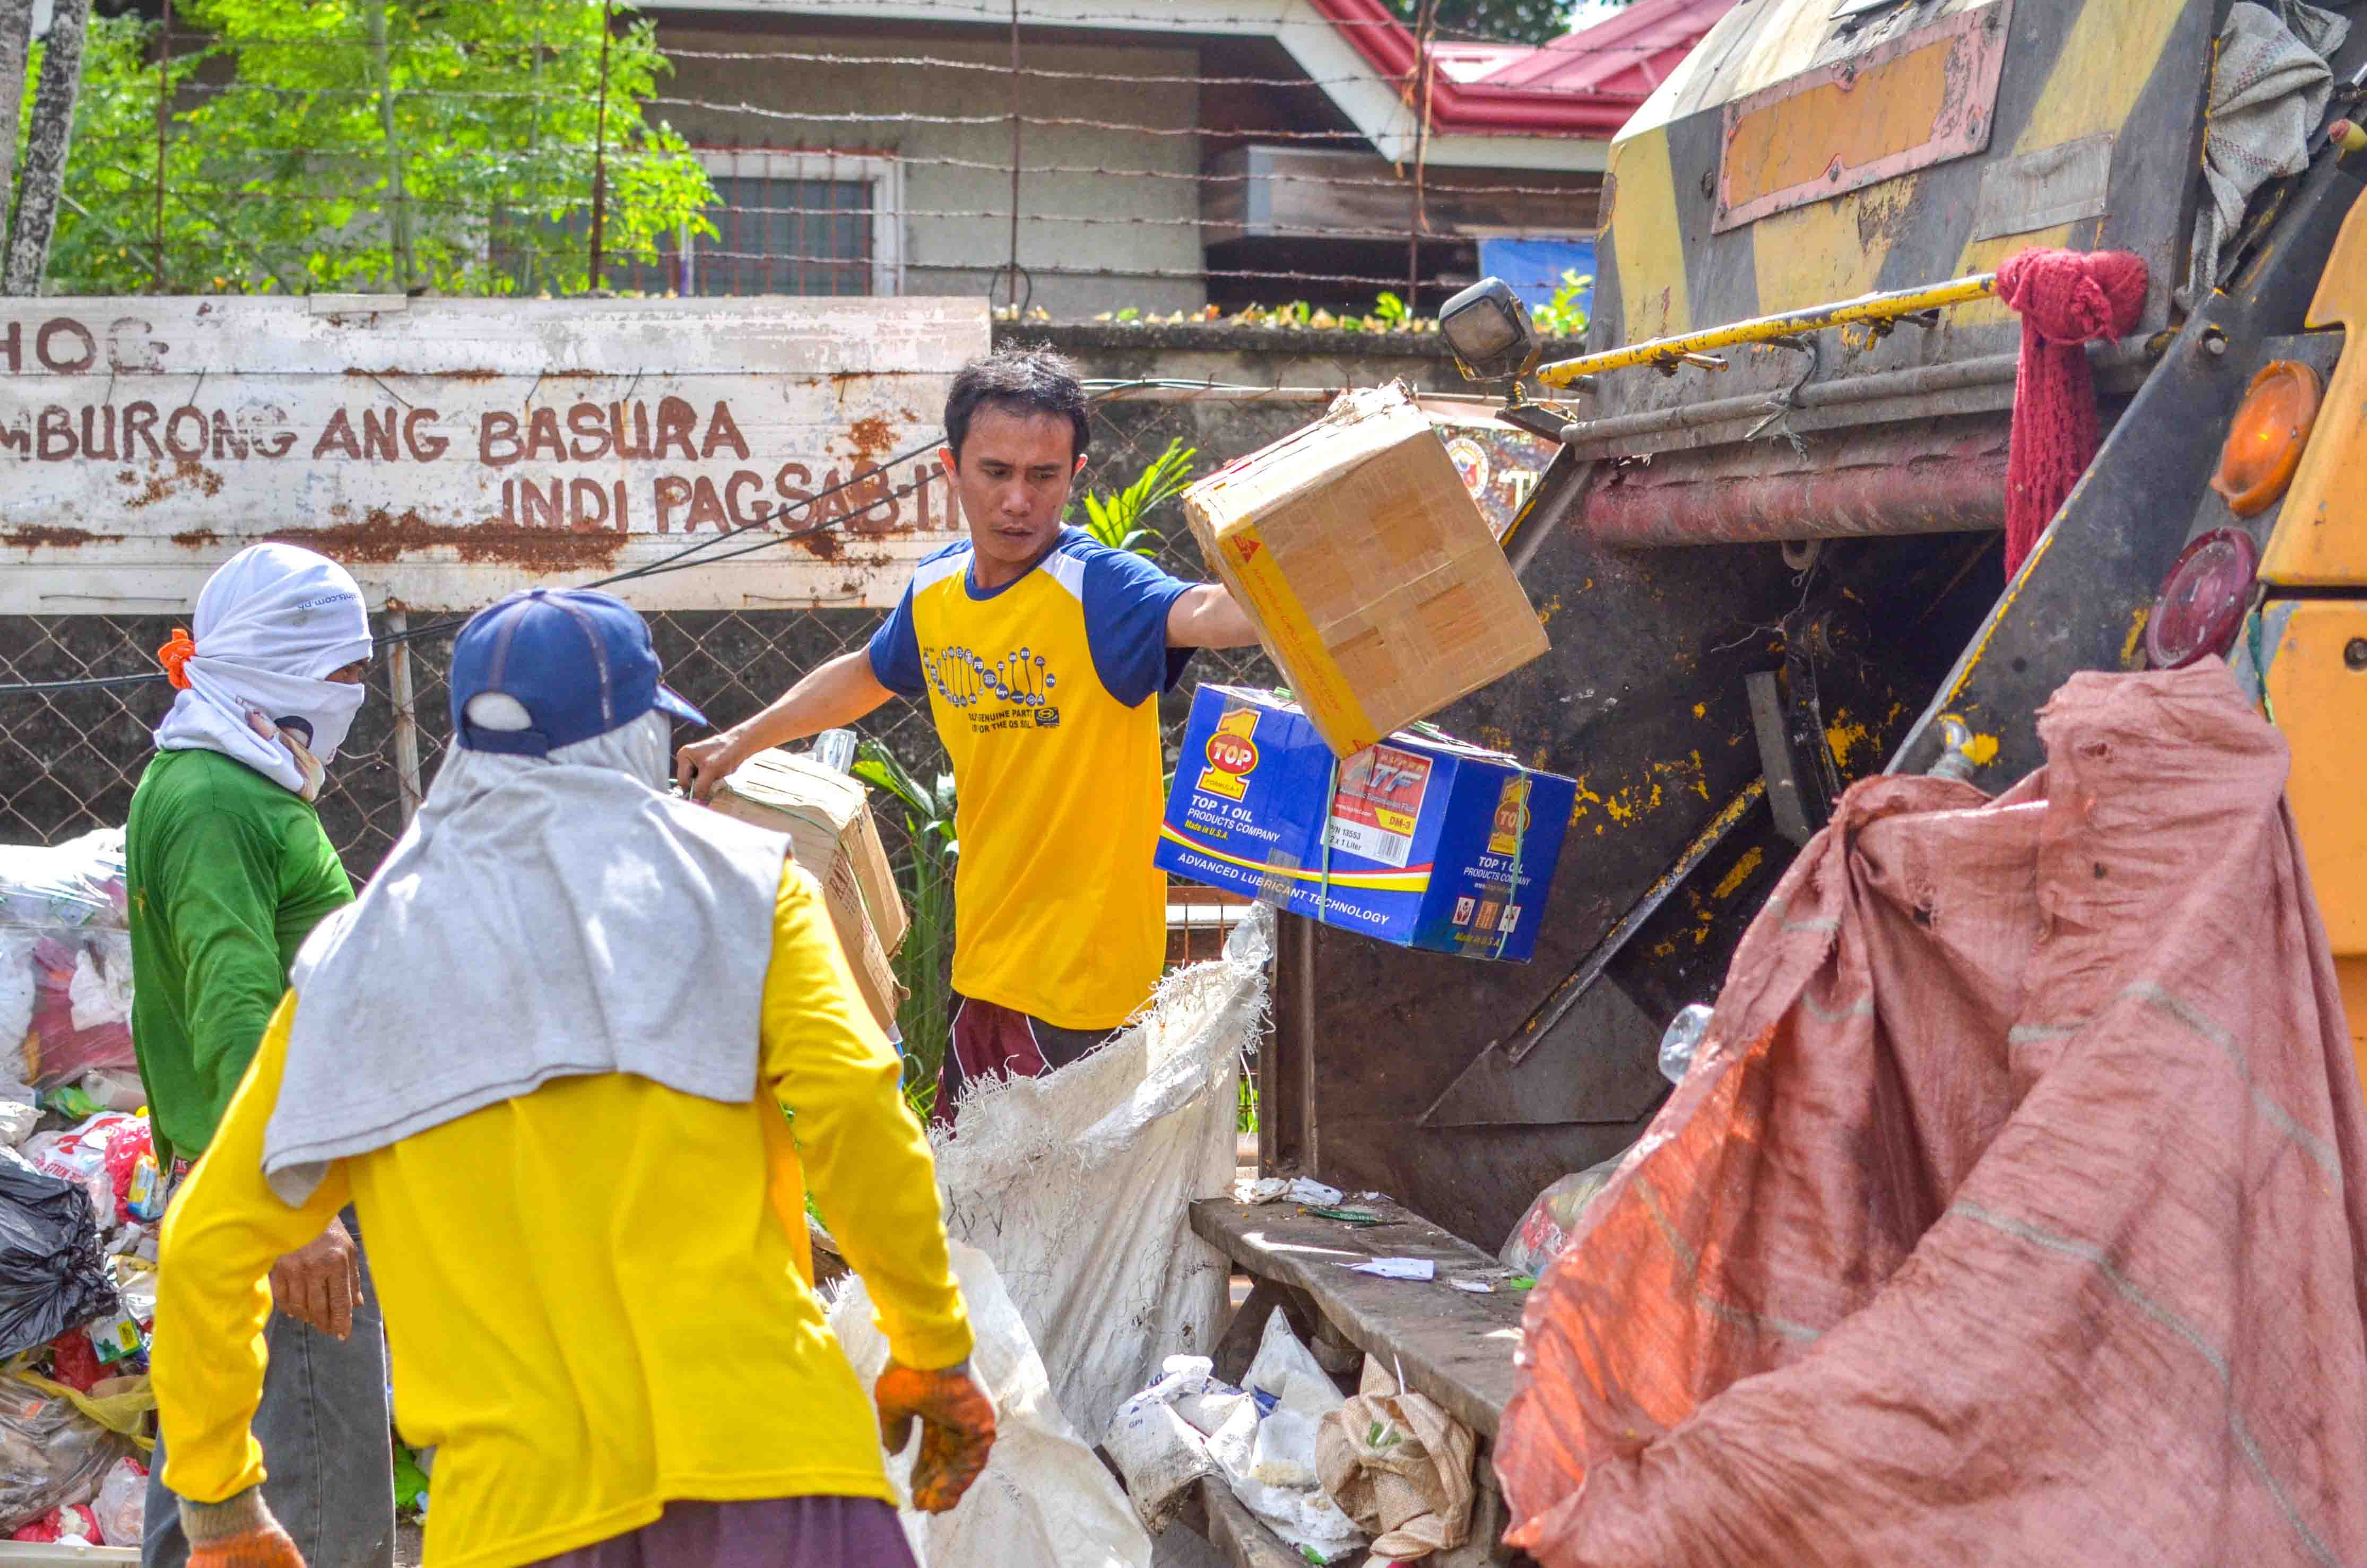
[{"x1": 1105, "y1": 1312, "x2": 1364, "y2": 1563}]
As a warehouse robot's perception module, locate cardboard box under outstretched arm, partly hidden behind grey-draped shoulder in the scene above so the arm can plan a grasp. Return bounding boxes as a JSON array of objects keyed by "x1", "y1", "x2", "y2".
[{"x1": 710, "y1": 751, "x2": 907, "y2": 1028}]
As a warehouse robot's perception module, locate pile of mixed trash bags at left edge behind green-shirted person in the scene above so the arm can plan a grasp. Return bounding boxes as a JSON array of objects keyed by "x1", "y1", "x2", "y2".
[{"x1": 0, "y1": 829, "x2": 163, "y2": 1547}]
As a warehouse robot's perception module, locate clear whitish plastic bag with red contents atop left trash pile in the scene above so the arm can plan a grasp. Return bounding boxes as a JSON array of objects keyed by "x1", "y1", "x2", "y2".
[{"x1": 0, "y1": 829, "x2": 140, "y2": 1089}]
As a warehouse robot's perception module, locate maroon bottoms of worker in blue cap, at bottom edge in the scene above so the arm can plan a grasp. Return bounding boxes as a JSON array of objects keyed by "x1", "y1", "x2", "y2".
[{"x1": 527, "y1": 1497, "x2": 914, "y2": 1568}]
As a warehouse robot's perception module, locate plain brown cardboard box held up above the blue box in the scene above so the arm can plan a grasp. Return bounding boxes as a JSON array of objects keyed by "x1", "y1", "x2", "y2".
[{"x1": 1184, "y1": 382, "x2": 1548, "y2": 756}]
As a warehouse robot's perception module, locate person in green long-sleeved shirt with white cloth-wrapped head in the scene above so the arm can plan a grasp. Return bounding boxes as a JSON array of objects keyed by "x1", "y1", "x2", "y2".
[{"x1": 123, "y1": 545, "x2": 395, "y2": 1568}]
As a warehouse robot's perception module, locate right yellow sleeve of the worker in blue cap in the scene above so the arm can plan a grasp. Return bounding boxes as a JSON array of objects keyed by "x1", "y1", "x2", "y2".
[{"x1": 762, "y1": 864, "x2": 970, "y2": 1372}]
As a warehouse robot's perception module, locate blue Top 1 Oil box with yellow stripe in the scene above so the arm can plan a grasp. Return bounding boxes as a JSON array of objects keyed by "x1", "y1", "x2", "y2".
[{"x1": 1155, "y1": 687, "x2": 1579, "y2": 961}]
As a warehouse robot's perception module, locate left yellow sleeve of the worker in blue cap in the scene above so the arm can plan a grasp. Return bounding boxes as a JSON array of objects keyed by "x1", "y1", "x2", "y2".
[{"x1": 149, "y1": 992, "x2": 348, "y2": 1502}]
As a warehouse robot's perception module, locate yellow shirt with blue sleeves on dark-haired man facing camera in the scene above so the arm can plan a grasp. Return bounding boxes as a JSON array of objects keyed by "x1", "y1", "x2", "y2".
[{"x1": 871, "y1": 528, "x2": 1191, "y2": 1030}]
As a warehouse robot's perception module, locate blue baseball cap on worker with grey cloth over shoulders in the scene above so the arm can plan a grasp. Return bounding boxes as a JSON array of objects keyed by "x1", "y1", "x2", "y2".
[{"x1": 450, "y1": 587, "x2": 708, "y2": 756}]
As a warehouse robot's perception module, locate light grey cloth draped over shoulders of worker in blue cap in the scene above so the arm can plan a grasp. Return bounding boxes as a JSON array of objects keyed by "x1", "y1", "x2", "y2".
[{"x1": 263, "y1": 696, "x2": 788, "y2": 1203}]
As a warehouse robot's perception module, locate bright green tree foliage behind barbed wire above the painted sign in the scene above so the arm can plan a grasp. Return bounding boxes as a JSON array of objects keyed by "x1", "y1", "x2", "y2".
[{"x1": 41, "y1": 0, "x2": 715, "y2": 294}]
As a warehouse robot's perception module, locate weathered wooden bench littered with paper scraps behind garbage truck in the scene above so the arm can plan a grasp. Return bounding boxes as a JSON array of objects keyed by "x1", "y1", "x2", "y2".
[{"x1": 1191, "y1": 1199, "x2": 1529, "y2": 1568}]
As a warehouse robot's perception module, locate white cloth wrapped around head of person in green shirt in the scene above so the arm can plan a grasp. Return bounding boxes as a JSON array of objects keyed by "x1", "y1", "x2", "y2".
[{"x1": 156, "y1": 545, "x2": 369, "y2": 801}]
